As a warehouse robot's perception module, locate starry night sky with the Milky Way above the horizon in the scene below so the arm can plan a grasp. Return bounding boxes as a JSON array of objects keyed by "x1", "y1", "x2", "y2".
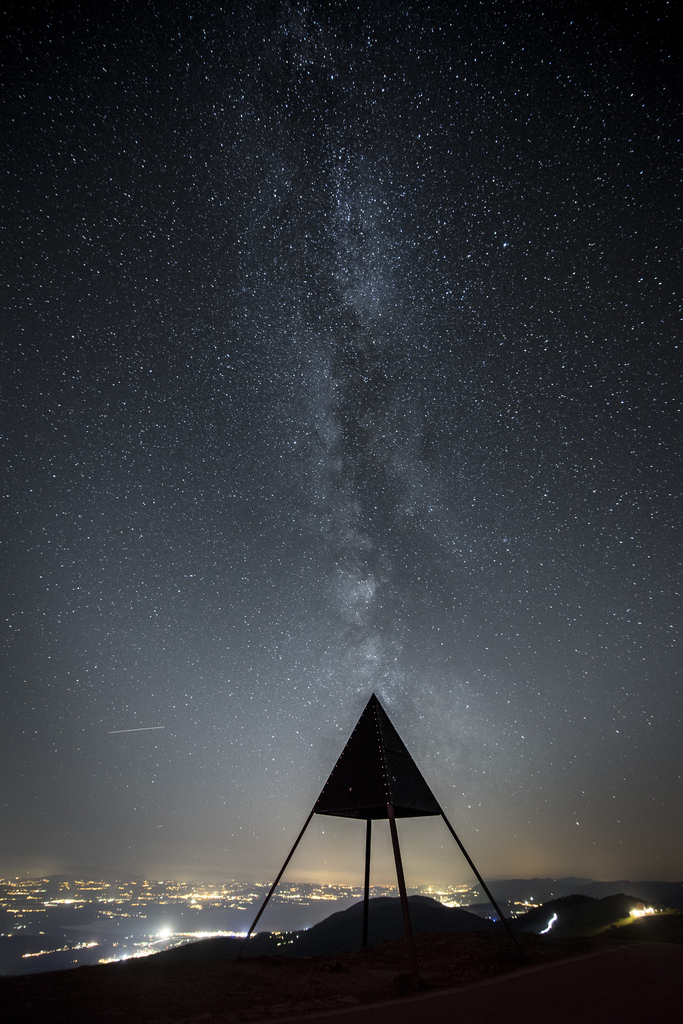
[{"x1": 0, "y1": 0, "x2": 683, "y2": 885}]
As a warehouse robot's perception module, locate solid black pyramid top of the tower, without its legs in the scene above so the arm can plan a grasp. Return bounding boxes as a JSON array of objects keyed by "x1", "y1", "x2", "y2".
[{"x1": 313, "y1": 693, "x2": 441, "y2": 820}]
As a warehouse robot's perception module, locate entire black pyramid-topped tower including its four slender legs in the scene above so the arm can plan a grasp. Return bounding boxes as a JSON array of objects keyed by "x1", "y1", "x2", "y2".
[{"x1": 245, "y1": 693, "x2": 518, "y2": 988}]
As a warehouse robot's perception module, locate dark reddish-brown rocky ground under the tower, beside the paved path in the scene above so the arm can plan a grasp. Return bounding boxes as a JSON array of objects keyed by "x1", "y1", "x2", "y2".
[{"x1": 0, "y1": 932, "x2": 591, "y2": 1024}]
